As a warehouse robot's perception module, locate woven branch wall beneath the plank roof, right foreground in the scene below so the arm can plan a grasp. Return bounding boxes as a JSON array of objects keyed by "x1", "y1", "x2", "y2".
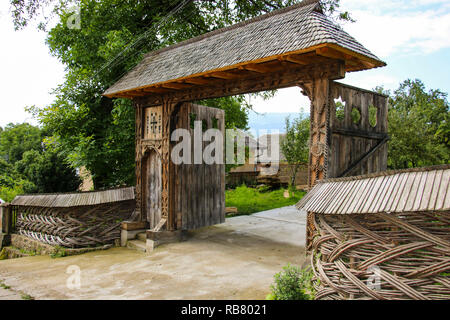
[{"x1": 311, "y1": 211, "x2": 450, "y2": 300}]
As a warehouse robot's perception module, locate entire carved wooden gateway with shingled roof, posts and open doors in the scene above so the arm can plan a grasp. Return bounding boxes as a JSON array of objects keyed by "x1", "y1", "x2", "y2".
[{"x1": 104, "y1": 0, "x2": 387, "y2": 238}]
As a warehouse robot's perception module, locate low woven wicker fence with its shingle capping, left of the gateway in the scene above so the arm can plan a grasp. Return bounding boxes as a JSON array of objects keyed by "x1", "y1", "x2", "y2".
[{"x1": 12, "y1": 188, "x2": 135, "y2": 248}]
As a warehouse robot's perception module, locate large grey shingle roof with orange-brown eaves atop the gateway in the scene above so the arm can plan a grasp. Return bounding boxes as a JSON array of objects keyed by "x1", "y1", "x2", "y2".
[{"x1": 104, "y1": 0, "x2": 386, "y2": 97}]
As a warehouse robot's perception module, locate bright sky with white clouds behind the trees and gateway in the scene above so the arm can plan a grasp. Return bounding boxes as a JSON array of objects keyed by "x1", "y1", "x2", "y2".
[{"x1": 0, "y1": 0, "x2": 450, "y2": 127}]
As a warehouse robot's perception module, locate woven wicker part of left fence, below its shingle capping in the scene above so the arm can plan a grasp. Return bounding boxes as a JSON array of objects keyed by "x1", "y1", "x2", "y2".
[{"x1": 13, "y1": 200, "x2": 135, "y2": 248}]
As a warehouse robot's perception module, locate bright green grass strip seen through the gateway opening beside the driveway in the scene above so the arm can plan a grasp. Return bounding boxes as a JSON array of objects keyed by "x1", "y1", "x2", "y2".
[{"x1": 225, "y1": 185, "x2": 306, "y2": 215}]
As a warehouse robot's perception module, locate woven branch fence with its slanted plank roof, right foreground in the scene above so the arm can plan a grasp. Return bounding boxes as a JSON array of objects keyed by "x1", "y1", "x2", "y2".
[{"x1": 297, "y1": 165, "x2": 450, "y2": 299}]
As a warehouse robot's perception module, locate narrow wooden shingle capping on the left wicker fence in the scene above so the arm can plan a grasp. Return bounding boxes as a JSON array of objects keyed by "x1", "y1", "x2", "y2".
[{"x1": 11, "y1": 187, "x2": 134, "y2": 208}]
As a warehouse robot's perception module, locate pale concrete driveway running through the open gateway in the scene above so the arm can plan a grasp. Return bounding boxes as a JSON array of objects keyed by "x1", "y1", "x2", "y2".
[{"x1": 0, "y1": 207, "x2": 306, "y2": 299}]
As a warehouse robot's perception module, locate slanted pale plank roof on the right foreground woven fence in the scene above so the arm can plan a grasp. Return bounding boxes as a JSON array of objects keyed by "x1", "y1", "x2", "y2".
[{"x1": 297, "y1": 165, "x2": 450, "y2": 214}]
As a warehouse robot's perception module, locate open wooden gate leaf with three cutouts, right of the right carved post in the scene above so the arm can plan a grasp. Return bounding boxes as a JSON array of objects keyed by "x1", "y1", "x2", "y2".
[{"x1": 327, "y1": 81, "x2": 388, "y2": 178}]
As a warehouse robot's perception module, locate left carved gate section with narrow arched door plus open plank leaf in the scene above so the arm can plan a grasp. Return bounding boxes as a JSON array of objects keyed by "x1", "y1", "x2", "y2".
[{"x1": 136, "y1": 103, "x2": 225, "y2": 231}]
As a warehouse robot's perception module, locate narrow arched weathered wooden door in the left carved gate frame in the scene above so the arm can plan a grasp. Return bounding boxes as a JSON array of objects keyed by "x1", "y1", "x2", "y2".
[{"x1": 144, "y1": 150, "x2": 161, "y2": 229}]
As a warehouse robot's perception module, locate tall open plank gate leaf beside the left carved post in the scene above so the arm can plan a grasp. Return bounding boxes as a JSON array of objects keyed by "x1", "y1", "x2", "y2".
[{"x1": 173, "y1": 103, "x2": 225, "y2": 230}]
